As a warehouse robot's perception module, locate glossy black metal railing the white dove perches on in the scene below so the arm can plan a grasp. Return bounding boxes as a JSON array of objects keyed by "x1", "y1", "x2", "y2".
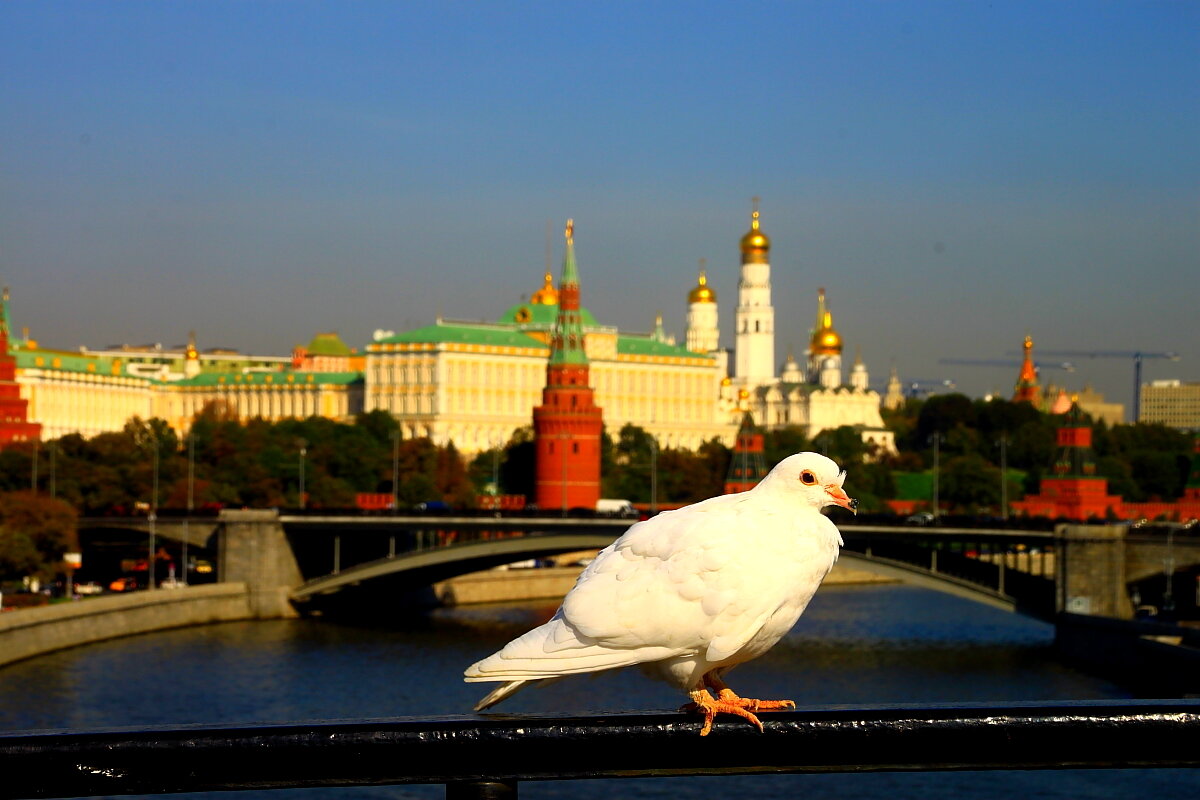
[{"x1": 0, "y1": 700, "x2": 1200, "y2": 800}]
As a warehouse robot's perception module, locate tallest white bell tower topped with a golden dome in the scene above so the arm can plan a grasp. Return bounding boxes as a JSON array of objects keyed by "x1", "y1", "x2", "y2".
[{"x1": 733, "y1": 198, "x2": 775, "y2": 386}]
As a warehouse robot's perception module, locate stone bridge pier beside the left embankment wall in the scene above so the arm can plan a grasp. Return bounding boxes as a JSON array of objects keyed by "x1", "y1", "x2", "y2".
[{"x1": 217, "y1": 510, "x2": 304, "y2": 619}]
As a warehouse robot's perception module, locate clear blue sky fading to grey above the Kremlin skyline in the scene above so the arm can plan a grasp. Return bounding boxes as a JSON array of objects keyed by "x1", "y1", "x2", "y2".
[{"x1": 0, "y1": 0, "x2": 1200, "y2": 419}]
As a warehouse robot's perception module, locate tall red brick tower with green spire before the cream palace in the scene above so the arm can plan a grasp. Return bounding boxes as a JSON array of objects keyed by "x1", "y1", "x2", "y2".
[{"x1": 533, "y1": 219, "x2": 604, "y2": 511}]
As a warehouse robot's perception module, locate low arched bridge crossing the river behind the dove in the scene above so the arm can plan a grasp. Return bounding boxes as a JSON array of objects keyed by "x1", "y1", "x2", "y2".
[{"x1": 80, "y1": 510, "x2": 1200, "y2": 621}]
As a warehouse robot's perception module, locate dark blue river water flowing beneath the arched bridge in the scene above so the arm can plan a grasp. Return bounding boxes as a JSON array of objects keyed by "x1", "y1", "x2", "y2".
[{"x1": 0, "y1": 585, "x2": 1200, "y2": 800}]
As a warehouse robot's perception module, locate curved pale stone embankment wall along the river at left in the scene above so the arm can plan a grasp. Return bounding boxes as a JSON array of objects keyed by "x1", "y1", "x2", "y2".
[{"x1": 0, "y1": 583, "x2": 254, "y2": 666}]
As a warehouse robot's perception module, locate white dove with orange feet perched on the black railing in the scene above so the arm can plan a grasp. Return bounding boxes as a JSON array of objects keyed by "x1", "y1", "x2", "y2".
[{"x1": 464, "y1": 452, "x2": 858, "y2": 736}]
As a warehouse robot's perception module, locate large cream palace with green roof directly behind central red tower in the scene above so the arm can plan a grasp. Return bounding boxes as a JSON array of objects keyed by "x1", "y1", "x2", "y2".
[{"x1": 365, "y1": 235, "x2": 737, "y2": 455}]
